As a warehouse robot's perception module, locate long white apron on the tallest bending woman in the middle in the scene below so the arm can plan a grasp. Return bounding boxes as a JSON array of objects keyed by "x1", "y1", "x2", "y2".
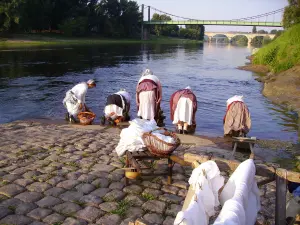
[{"x1": 138, "y1": 91, "x2": 156, "y2": 120}]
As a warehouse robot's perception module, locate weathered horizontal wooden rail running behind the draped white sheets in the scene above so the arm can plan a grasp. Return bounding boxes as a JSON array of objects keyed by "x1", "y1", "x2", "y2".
[{"x1": 184, "y1": 153, "x2": 300, "y2": 183}]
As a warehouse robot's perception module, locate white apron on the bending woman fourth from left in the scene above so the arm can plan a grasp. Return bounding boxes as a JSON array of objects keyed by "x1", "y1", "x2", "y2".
[{"x1": 173, "y1": 97, "x2": 193, "y2": 125}]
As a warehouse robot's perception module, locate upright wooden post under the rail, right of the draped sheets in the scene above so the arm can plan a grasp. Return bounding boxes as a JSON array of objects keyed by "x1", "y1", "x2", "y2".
[{"x1": 275, "y1": 175, "x2": 287, "y2": 225}]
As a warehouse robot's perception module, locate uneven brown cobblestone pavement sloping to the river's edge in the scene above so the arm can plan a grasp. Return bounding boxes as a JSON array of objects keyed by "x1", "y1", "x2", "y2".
[{"x1": 0, "y1": 122, "x2": 275, "y2": 225}]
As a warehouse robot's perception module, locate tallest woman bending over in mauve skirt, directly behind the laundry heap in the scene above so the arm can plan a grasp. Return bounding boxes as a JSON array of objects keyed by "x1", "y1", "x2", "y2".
[{"x1": 136, "y1": 69, "x2": 162, "y2": 120}]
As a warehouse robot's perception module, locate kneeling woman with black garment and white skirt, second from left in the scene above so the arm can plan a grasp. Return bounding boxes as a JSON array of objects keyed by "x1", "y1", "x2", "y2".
[{"x1": 103, "y1": 90, "x2": 131, "y2": 124}]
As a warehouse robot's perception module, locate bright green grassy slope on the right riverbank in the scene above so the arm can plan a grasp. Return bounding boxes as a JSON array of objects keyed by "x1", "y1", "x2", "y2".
[{"x1": 253, "y1": 24, "x2": 300, "y2": 73}]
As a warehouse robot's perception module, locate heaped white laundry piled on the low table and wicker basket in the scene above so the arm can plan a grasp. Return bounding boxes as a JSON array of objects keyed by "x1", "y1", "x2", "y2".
[{"x1": 116, "y1": 119, "x2": 158, "y2": 156}]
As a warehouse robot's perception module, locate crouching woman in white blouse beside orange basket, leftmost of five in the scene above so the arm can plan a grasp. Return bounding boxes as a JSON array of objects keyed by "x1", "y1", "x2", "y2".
[{"x1": 63, "y1": 79, "x2": 96, "y2": 123}]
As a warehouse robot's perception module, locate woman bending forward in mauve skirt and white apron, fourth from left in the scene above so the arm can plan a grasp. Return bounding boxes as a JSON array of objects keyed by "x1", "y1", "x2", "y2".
[{"x1": 170, "y1": 87, "x2": 197, "y2": 134}]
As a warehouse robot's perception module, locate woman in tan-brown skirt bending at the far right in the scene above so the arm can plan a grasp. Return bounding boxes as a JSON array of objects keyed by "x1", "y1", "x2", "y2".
[{"x1": 223, "y1": 95, "x2": 251, "y2": 137}]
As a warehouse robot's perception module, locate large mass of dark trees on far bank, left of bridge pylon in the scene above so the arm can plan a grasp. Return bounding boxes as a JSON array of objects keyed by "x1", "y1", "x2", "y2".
[{"x1": 0, "y1": 0, "x2": 142, "y2": 37}]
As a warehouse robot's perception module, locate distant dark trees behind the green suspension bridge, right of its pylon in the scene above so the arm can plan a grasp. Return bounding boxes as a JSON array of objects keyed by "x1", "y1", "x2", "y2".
[{"x1": 150, "y1": 13, "x2": 204, "y2": 40}]
